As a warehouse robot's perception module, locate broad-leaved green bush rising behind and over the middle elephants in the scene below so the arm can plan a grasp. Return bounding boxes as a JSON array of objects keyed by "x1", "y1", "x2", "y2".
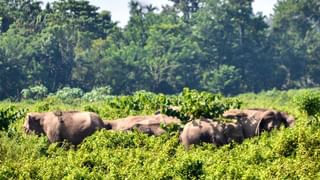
[{"x1": 107, "y1": 88, "x2": 241, "y2": 122}]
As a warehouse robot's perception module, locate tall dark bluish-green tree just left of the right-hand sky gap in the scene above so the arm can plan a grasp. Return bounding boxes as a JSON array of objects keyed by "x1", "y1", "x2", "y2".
[{"x1": 193, "y1": 0, "x2": 273, "y2": 92}]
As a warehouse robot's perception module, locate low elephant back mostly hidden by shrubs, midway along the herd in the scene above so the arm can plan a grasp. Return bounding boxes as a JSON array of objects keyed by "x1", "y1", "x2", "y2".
[{"x1": 104, "y1": 114, "x2": 181, "y2": 135}]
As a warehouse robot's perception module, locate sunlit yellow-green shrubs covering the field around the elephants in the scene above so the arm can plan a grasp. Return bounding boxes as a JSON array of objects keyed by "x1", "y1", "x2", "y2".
[{"x1": 0, "y1": 89, "x2": 320, "y2": 179}]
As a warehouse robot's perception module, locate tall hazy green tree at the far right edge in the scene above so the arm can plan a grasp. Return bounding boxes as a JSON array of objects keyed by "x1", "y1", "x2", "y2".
[{"x1": 271, "y1": 0, "x2": 320, "y2": 89}]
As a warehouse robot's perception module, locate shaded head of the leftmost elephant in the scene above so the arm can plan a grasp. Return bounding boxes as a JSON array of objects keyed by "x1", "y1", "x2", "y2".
[{"x1": 23, "y1": 113, "x2": 45, "y2": 135}]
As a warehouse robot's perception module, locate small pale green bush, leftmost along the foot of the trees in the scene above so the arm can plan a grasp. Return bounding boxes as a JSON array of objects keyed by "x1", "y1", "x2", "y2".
[{"x1": 21, "y1": 84, "x2": 48, "y2": 100}]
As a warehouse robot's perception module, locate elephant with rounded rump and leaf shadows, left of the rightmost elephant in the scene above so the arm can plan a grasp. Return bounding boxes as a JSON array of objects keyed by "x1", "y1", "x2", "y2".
[{"x1": 179, "y1": 119, "x2": 244, "y2": 149}]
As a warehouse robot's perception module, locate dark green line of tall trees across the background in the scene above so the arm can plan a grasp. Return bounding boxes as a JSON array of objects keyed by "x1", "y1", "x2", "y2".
[{"x1": 0, "y1": 0, "x2": 320, "y2": 99}]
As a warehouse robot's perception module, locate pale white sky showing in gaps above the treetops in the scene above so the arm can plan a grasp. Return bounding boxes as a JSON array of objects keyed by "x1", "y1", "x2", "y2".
[{"x1": 43, "y1": 0, "x2": 277, "y2": 26}]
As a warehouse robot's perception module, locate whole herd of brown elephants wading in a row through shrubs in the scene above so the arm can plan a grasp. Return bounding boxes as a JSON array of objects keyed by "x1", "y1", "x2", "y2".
[{"x1": 23, "y1": 109, "x2": 295, "y2": 149}]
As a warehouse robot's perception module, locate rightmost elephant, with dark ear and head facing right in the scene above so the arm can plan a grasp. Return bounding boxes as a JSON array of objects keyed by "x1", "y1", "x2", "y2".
[{"x1": 223, "y1": 108, "x2": 295, "y2": 138}]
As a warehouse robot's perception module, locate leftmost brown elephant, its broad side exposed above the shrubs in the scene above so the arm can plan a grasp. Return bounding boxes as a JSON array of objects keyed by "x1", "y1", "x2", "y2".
[{"x1": 23, "y1": 111, "x2": 105, "y2": 145}]
